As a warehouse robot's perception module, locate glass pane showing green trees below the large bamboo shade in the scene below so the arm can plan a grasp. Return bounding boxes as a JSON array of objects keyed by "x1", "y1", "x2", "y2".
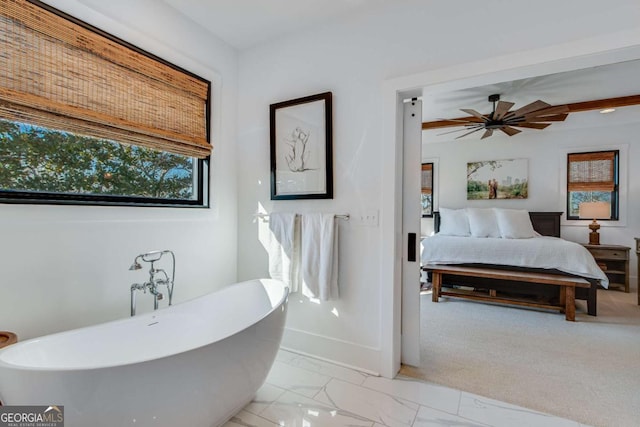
[{"x1": 0, "y1": 120, "x2": 205, "y2": 205}]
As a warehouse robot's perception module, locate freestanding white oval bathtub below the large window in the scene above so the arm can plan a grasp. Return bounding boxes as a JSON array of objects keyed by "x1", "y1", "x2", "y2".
[{"x1": 0, "y1": 279, "x2": 289, "y2": 427}]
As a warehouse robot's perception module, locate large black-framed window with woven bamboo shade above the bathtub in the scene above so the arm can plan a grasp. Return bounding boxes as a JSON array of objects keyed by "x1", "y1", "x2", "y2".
[{"x1": 0, "y1": 0, "x2": 212, "y2": 206}]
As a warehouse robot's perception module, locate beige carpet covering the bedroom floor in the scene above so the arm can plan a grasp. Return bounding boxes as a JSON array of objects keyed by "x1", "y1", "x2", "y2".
[{"x1": 401, "y1": 288, "x2": 640, "y2": 427}]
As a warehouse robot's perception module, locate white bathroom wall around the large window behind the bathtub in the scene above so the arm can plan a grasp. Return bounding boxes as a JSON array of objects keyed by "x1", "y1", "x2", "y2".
[{"x1": 0, "y1": 0, "x2": 237, "y2": 339}]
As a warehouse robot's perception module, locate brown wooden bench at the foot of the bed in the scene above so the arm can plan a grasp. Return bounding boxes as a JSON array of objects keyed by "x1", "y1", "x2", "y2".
[{"x1": 424, "y1": 265, "x2": 591, "y2": 321}]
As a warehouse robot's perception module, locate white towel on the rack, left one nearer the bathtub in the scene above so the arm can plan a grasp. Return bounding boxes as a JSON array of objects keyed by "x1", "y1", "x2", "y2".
[{"x1": 267, "y1": 212, "x2": 300, "y2": 292}]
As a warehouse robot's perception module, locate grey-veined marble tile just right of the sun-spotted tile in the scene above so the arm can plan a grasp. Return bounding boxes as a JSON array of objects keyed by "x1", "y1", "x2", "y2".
[{"x1": 314, "y1": 379, "x2": 419, "y2": 427}]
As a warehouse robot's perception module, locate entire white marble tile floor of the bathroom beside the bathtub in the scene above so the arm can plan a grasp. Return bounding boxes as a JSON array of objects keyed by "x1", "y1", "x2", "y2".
[{"x1": 232, "y1": 350, "x2": 588, "y2": 427}]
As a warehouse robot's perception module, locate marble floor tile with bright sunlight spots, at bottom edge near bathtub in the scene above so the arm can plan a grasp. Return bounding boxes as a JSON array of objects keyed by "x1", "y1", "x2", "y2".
[{"x1": 260, "y1": 392, "x2": 373, "y2": 427}]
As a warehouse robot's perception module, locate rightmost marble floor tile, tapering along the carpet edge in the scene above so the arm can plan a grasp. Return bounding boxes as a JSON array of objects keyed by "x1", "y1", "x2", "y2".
[{"x1": 458, "y1": 392, "x2": 580, "y2": 427}]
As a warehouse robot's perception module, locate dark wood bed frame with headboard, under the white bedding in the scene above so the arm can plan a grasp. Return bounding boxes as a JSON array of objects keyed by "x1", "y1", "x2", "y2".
[{"x1": 433, "y1": 212, "x2": 599, "y2": 316}]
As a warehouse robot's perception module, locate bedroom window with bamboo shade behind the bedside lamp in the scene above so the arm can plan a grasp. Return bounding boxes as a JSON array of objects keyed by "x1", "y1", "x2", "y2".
[{"x1": 567, "y1": 150, "x2": 620, "y2": 220}]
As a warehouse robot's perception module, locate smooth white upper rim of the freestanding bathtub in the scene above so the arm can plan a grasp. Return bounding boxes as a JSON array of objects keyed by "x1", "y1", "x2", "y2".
[{"x1": 0, "y1": 278, "x2": 290, "y2": 372}]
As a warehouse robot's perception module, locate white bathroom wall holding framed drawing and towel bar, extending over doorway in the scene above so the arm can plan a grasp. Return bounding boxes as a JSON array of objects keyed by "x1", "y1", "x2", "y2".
[{"x1": 238, "y1": 1, "x2": 638, "y2": 374}]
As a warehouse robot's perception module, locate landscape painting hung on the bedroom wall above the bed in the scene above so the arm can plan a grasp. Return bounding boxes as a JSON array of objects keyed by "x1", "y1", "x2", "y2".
[{"x1": 467, "y1": 159, "x2": 529, "y2": 200}]
